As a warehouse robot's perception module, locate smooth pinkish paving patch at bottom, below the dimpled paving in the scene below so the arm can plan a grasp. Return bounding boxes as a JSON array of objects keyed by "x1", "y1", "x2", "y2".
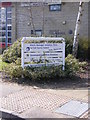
[{"x1": 20, "y1": 107, "x2": 73, "y2": 118}]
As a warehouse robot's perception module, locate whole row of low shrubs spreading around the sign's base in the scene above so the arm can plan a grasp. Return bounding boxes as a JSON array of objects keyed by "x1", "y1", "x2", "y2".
[{"x1": 3, "y1": 54, "x2": 86, "y2": 81}]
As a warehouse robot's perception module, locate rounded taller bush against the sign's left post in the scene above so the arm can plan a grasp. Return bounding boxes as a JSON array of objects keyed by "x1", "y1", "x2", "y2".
[{"x1": 2, "y1": 39, "x2": 21, "y2": 63}]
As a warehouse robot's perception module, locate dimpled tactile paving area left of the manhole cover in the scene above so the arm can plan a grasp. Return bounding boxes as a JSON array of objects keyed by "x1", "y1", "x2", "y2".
[{"x1": 1, "y1": 89, "x2": 70, "y2": 113}]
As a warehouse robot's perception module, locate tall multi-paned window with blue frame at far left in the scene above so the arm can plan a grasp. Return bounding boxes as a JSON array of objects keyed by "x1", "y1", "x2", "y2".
[{"x1": 0, "y1": 7, "x2": 12, "y2": 46}]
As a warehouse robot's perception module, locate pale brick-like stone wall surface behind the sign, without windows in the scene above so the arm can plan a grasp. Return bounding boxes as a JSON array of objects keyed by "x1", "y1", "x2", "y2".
[{"x1": 12, "y1": 2, "x2": 88, "y2": 40}]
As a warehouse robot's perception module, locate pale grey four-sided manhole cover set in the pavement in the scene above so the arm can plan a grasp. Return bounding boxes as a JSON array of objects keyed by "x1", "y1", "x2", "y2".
[{"x1": 56, "y1": 100, "x2": 88, "y2": 117}]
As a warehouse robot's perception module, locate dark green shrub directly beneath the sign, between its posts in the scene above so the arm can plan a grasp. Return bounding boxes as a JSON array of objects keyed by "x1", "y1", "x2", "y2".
[{"x1": 23, "y1": 66, "x2": 62, "y2": 81}]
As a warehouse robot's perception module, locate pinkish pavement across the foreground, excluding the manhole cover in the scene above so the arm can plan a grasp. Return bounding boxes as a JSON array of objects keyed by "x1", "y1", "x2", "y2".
[{"x1": 0, "y1": 76, "x2": 89, "y2": 120}]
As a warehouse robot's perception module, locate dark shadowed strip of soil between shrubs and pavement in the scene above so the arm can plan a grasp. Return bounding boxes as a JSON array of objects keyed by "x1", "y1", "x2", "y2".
[{"x1": 3, "y1": 71, "x2": 90, "y2": 90}]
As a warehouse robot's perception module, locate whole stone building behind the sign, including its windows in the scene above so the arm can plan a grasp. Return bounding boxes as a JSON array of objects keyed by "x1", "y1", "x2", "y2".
[{"x1": 0, "y1": 0, "x2": 88, "y2": 44}]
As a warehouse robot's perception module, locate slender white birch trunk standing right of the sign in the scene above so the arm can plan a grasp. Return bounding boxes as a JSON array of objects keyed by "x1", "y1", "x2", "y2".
[{"x1": 73, "y1": 0, "x2": 83, "y2": 57}]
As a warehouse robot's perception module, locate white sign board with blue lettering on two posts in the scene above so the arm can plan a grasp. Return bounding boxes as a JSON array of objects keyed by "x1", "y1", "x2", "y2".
[{"x1": 21, "y1": 37, "x2": 65, "y2": 70}]
